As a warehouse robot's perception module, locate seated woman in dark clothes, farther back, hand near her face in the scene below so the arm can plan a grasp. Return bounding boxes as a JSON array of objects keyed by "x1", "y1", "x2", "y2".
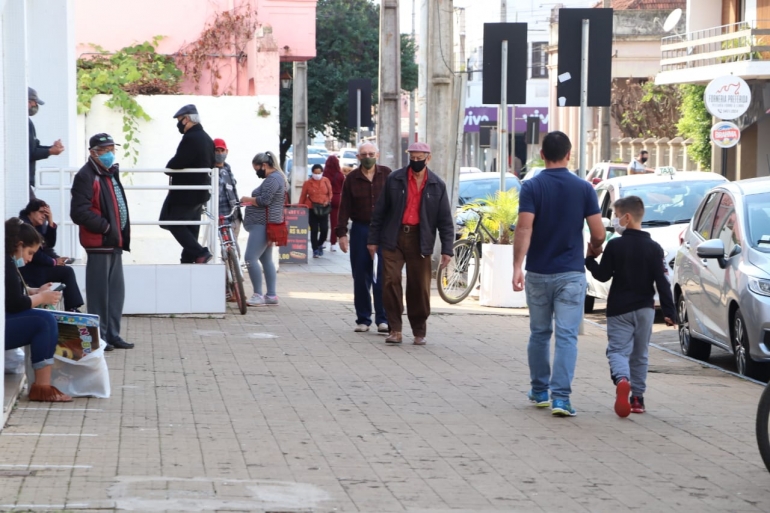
[{"x1": 19, "y1": 199, "x2": 83, "y2": 312}]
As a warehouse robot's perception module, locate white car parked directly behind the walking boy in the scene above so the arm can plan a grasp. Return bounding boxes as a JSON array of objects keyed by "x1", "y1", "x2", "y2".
[{"x1": 584, "y1": 171, "x2": 727, "y2": 312}]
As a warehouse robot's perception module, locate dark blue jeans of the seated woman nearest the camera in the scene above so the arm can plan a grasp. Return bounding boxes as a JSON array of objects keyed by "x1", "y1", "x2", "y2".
[{"x1": 5, "y1": 308, "x2": 59, "y2": 370}]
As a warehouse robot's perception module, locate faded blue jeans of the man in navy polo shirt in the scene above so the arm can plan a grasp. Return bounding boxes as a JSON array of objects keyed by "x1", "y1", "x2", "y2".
[{"x1": 524, "y1": 272, "x2": 586, "y2": 399}]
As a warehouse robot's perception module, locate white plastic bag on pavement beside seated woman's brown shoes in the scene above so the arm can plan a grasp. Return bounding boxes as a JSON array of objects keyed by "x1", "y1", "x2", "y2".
[{"x1": 51, "y1": 341, "x2": 110, "y2": 399}]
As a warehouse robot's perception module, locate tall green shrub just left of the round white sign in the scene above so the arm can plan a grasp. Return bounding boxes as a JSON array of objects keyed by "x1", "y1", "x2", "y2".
[{"x1": 676, "y1": 84, "x2": 712, "y2": 169}]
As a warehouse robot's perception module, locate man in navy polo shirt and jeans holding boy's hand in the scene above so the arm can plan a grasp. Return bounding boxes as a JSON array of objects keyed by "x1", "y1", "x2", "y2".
[{"x1": 513, "y1": 132, "x2": 605, "y2": 417}]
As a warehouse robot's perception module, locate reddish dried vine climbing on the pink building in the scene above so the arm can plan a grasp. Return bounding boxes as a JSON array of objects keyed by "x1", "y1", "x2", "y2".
[{"x1": 175, "y1": 7, "x2": 257, "y2": 96}]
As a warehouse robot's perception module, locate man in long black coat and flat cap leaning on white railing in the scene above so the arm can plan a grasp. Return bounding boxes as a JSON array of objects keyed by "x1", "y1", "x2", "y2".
[{"x1": 160, "y1": 105, "x2": 215, "y2": 264}]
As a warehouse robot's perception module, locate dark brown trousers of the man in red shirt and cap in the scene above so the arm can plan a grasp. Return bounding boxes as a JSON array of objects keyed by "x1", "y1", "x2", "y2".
[{"x1": 382, "y1": 227, "x2": 431, "y2": 337}]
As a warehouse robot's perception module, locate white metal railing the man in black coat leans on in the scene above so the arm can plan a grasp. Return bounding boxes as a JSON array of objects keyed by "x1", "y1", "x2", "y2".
[{"x1": 35, "y1": 167, "x2": 221, "y2": 263}]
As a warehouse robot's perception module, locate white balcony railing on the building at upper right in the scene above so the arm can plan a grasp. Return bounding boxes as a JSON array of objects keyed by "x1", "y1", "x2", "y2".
[{"x1": 660, "y1": 20, "x2": 770, "y2": 71}]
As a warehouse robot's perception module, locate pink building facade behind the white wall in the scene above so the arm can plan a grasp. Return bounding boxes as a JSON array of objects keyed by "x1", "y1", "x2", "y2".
[{"x1": 75, "y1": 0, "x2": 316, "y2": 96}]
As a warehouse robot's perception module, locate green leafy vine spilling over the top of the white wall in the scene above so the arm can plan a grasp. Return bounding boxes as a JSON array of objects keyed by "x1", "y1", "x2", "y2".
[{"x1": 77, "y1": 36, "x2": 182, "y2": 163}]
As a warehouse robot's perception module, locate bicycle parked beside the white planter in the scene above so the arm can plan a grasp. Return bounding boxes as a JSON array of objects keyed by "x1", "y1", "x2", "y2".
[{"x1": 436, "y1": 208, "x2": 497, "y2": 305}]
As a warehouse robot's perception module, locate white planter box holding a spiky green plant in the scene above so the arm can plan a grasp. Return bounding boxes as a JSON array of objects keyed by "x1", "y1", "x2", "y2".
[{"x1": 479, "y1": 244, "x2": 527, "y2": 308}]
